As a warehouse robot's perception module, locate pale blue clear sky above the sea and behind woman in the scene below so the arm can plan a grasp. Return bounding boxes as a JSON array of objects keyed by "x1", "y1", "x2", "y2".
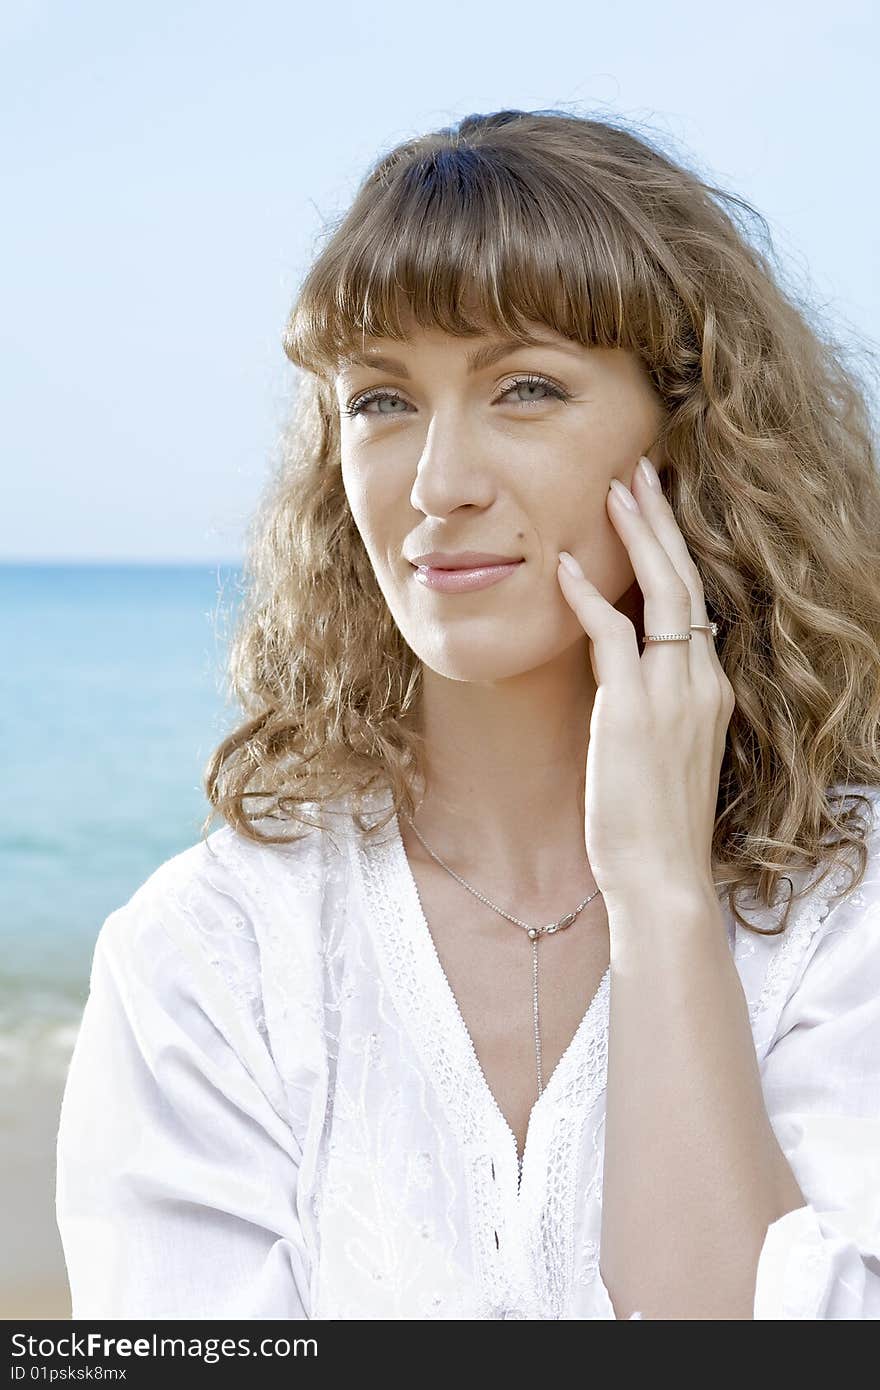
[{"x1": 0, "y1": 0, "x2": 880, "y2": 564}]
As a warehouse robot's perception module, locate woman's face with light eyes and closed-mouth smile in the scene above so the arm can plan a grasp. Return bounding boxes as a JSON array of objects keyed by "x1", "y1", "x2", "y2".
[{"x1": 335, "y1": 316, "x2": 663, "y2": 682}]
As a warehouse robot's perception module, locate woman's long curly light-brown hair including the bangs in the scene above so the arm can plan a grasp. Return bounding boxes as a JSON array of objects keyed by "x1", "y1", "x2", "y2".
[{"x1": 203, "y1": 110, "x2": 880, "y2": 931}]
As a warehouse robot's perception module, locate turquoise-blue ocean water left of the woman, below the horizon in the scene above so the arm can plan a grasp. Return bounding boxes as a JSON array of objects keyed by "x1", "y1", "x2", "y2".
[{"x1": 0, "y1": 564, "x2": 247, "y2": 1084}]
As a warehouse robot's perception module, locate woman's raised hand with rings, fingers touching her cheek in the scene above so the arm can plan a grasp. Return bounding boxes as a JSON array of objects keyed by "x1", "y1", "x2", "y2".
[{"x1": 557, "y1": 460, "x2": 735, "y2": 908}]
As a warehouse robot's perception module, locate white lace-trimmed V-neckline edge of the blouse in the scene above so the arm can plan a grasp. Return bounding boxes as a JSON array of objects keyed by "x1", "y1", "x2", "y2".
[{"x1": 386, "y1": 815, "x2": 612, "y2": 1195}]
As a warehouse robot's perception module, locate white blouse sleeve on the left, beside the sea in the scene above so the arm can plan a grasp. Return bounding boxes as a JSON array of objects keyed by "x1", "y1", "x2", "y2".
[{"x1": 56, "y1": 872, "x2": 315, "y2": 1319}]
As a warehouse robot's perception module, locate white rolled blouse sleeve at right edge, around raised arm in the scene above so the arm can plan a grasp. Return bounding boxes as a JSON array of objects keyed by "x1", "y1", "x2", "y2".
[{"x1": 753, "y1": 853, "x2": 880, "y2": 1319}]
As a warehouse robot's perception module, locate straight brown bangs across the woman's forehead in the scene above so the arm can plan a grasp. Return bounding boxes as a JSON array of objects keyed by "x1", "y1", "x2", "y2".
[{"x1": 282, "y1": 132, "x2": 662, "y2": 378}]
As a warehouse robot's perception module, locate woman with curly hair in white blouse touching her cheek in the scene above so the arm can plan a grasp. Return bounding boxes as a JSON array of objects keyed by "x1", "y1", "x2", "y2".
[{"x1": 57, "y1": 111, "x2": 880, "y2": 1319}]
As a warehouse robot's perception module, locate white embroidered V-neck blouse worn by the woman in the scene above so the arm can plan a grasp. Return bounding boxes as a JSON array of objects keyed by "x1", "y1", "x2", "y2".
[{"x1": 56, "y1": 787, "x2": 880, "y2": 1319}]
